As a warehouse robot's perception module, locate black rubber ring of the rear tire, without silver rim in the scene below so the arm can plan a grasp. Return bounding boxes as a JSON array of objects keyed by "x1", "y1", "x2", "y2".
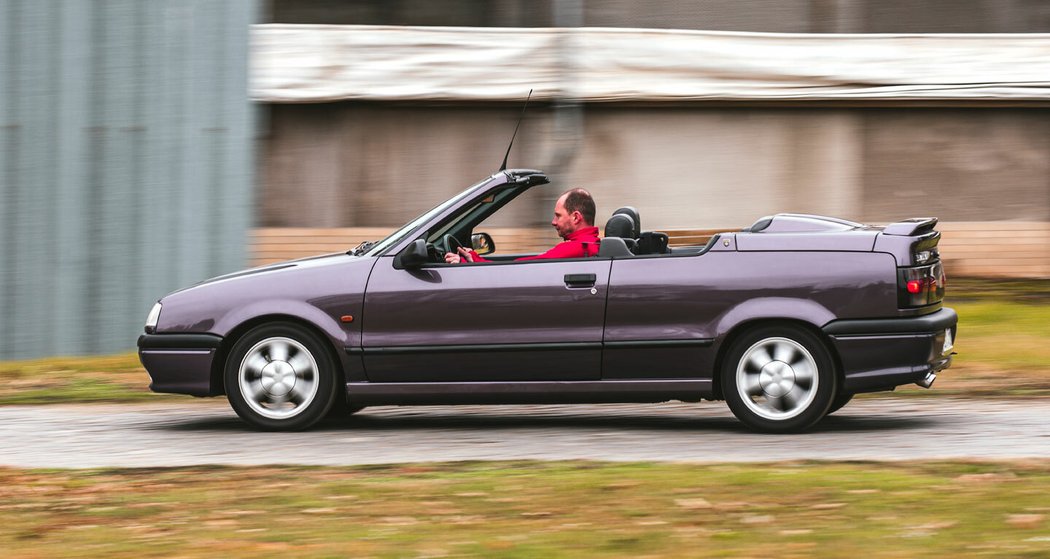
[{"x1": 721, "y1": 325, "x2": 838, "y2": 433}]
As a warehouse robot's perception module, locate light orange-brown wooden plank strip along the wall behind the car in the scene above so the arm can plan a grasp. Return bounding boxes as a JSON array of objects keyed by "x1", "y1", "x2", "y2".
[{"x1": 251, "y1": 222, "x2": 1050, "y2": 277}]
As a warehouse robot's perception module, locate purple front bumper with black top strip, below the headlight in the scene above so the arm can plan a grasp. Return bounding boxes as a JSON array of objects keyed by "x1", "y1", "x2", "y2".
[{"x1": 139, "y1": 334, "x2": 223, "y2": 396}]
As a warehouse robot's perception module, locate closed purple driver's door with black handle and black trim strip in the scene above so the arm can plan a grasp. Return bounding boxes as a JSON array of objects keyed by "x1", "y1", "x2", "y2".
[{"x1": 361, "y1": 256, "x2": 611, "y2": 382}]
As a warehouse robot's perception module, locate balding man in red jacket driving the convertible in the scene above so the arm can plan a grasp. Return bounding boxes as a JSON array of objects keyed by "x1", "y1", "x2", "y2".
[{"x1": 445, "y1": 188, "x2": 600, "y2": 264}]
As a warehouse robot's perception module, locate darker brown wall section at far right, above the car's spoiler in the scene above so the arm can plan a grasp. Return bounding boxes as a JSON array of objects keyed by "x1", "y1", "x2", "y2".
[{"x1": 860, "y1": 108, "x2": 1050, "y2": 222}]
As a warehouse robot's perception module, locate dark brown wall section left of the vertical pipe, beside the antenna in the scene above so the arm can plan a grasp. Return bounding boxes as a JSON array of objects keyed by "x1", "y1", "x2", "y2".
[{"x1": 258, "y1": 103, "x2": 546, "y2": 227}]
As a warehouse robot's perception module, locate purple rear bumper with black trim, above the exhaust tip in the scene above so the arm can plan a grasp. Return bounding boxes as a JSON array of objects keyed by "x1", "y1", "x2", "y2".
[{"x1": 823, "y1": 308, "x2": 959, "y2": 393}]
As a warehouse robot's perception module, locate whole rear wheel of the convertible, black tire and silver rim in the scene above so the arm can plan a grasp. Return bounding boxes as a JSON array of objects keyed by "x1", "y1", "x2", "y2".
[{"x1": 721, "y1": 325, "x2": 838, "y2": 433}]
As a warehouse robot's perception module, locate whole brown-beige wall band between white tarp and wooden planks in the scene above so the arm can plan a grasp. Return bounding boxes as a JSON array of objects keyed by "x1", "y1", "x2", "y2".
[{"x1": 260, "y1": 103, "x2": 1050, "y2": 229}]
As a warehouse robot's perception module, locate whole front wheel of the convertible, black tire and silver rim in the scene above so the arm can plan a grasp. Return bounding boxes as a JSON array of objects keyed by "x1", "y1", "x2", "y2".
[{"x1": 225, "y1": 323, "x2": 339, "y2": 431}]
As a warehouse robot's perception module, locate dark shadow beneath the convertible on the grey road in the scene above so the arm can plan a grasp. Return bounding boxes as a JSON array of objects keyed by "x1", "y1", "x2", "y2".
[{"x1": 161, "y1": 408, "x2": 938, "y2": 436}]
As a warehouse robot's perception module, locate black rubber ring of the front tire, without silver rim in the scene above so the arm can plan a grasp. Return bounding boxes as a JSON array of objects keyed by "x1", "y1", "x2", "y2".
[{"x1": 224, "y1": 323, "x2": 338, "y2": 431}]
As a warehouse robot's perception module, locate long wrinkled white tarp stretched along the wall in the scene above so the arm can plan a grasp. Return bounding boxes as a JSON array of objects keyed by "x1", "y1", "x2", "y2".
[{"x1": 251, "y1": 24, "x2": 1050, "y2": 103}]
